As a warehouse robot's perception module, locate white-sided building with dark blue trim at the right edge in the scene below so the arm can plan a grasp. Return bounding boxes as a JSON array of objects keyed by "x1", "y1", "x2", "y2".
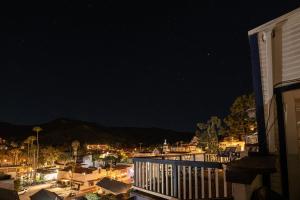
[{"x1": 248, "y1": 8, "x2": 300, "y2": 199}]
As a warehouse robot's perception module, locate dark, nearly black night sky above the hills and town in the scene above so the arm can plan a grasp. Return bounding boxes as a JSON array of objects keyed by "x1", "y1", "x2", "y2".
[{"x1": 0, "y1": 0, "x2": 299, "y2": 131}]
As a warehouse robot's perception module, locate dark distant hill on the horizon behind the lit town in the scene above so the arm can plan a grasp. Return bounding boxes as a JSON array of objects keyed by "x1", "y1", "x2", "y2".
[{"x1": 0, "y1": 118, "x2": 194, "y2": 145}]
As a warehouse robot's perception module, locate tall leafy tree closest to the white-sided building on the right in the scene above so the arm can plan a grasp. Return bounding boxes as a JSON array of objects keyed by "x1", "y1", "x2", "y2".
[{"x1": 224, "y1": 94, "x2": 256, "y2": 139}]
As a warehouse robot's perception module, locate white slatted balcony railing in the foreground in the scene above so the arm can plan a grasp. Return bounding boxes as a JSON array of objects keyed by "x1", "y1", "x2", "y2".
[{"x1": 133, "y1": 158, "x2": 231, "y2": 199}]
